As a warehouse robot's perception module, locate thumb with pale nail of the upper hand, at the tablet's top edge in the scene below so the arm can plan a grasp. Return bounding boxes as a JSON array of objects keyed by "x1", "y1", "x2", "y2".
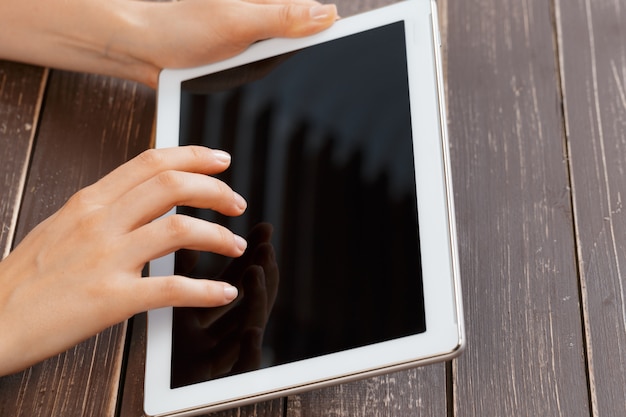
[{"x1": 238, "y1": 2, "x2": 338, "y2": 42}]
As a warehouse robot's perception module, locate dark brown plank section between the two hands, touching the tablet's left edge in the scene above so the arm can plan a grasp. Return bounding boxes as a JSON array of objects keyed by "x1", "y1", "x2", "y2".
[{"x1": 12, "y1": 72, "x2": 155, "y2": 228}]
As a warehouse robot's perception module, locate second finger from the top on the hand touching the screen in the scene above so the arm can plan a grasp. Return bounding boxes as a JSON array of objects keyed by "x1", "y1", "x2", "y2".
[{"x1": 112, "y1": 171, "x2": 247, "y2": 230}]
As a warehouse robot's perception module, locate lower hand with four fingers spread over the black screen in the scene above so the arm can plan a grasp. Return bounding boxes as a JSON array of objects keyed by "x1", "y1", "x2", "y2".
[{"x1": 0, "y1": 147, "x2": 247, "y2": 375}]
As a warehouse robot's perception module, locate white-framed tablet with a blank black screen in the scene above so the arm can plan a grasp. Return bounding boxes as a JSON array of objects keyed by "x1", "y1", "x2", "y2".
[{"x1": 145, "y1": 0, "x2": 464, "y2": 416}]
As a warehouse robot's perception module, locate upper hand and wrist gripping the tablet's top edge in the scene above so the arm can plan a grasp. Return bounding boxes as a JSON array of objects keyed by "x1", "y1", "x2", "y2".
[{"x1": 0, "y1": 0, "x2": 337, "y2": 87}]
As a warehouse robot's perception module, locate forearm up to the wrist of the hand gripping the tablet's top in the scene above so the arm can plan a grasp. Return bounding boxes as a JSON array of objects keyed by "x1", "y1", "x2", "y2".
[{"x1": 0, "y1": 0, "x2": 158, "y2": 80}]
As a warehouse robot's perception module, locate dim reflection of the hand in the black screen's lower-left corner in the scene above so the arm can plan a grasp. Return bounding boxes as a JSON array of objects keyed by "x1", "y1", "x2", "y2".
[{"x1": 172, "y1": 223, "x2": 279, "y2": 388}]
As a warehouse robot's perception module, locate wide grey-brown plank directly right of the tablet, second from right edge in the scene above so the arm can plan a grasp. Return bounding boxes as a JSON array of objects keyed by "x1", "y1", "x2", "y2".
[{"x1": 446, "y1": 0, "x2": 588, "y2": 417}]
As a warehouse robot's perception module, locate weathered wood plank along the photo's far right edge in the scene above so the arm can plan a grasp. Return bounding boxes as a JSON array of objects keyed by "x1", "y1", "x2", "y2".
[{"x1": 556, "y1": 0, "x2": 626, "y2": 416}]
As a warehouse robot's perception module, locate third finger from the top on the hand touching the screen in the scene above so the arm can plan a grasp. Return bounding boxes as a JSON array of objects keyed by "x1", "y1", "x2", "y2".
[{"x1": 121, "y1": 214, "x2": 247, "y2": 263}]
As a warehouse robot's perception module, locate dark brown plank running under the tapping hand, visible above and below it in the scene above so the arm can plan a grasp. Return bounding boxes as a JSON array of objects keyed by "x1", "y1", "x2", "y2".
[{"x1": 0, "y1": 72, "x2": 155, "y2": 416}]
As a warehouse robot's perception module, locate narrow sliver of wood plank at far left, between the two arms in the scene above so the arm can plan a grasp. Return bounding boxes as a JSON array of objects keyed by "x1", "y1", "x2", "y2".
[{"x1": 0, "y1": 61, "x2": 47, "y2": 259}]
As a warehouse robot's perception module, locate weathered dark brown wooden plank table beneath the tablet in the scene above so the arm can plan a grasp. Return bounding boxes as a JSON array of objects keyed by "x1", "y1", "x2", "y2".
[{"x1": 0, "y1": 0, "x2": 626, "y2": 417}]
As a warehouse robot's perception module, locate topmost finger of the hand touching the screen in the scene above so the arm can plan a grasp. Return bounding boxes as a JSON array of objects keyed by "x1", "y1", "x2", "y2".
[{"x1": 88, "y1": 146, "x2": 230, "y2": 204}]
